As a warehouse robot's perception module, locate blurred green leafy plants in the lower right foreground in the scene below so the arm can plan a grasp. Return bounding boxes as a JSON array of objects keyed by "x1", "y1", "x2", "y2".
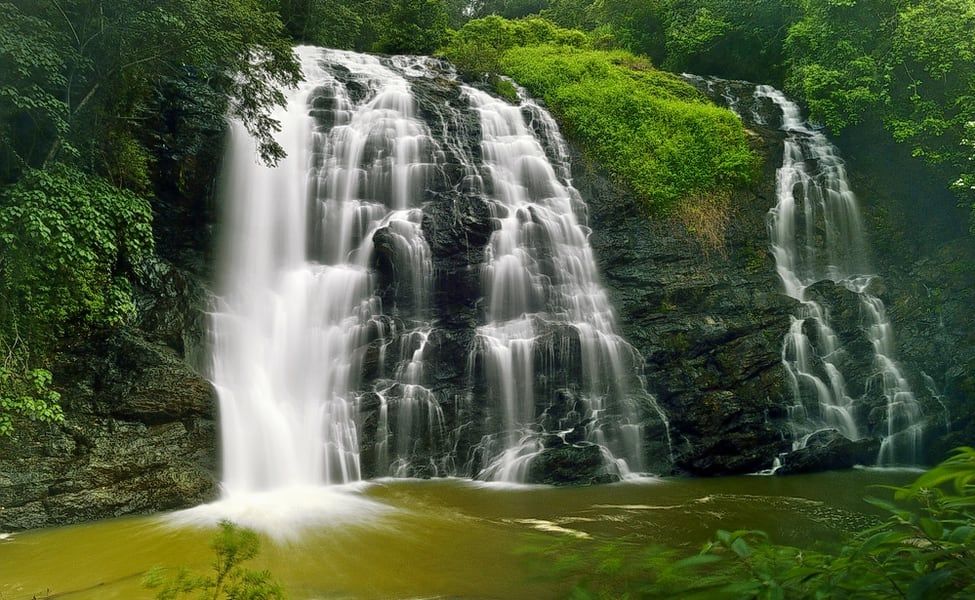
[{"x1": 530, "y1": 448, "x2": 975, "y2": 600}]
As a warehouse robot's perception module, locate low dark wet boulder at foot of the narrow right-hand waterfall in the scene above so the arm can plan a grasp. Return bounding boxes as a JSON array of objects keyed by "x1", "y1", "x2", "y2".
[{"x1": 775, "y1": 429, "x2": 880, "y2": 475}]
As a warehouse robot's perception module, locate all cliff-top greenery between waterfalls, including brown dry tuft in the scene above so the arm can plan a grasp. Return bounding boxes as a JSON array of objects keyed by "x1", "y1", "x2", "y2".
[{"x1": 440, "y1": 15, "x2": 757, "y2": 244}]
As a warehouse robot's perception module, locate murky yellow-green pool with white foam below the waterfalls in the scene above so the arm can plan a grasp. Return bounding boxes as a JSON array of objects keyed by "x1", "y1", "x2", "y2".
[{"x1": 0, "y1": 470, "x2": 915, "y2": 600}]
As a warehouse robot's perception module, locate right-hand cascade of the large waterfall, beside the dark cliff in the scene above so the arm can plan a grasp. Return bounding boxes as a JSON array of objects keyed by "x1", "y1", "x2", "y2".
[{"x1": 465, "y1": 88, "x2": 666, "y2": 481}]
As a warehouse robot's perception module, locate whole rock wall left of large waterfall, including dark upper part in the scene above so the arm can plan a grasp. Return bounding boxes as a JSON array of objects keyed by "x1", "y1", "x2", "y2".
[{"x1": 0, "y1": 138, "x2": 219, "y2": 531}]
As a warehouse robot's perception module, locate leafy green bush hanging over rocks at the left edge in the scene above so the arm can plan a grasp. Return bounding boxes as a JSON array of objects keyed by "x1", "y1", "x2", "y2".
[{"x1": 0, "y1": 165, "x2": 153, "y2": 434}]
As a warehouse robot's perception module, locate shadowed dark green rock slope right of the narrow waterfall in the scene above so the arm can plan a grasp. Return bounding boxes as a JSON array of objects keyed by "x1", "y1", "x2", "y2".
[{"x1": 840, "y1": 136, "x2": 975, "y2": 464}]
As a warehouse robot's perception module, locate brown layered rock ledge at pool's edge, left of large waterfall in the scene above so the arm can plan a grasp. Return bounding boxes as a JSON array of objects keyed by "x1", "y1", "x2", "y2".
[{"x1": 0, "y1": 298, "x2": 217, "y2": 530}]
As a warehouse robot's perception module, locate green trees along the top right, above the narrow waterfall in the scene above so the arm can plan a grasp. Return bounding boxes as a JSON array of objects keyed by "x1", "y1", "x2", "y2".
[{"x1": 456, "y1": 0, "x2": 975, "y2": 227}]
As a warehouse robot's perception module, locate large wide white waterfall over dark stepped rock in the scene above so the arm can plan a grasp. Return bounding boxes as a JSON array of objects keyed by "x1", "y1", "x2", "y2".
[{"x1": 211, "y1": 47, "x2": 666, "y2": 496}]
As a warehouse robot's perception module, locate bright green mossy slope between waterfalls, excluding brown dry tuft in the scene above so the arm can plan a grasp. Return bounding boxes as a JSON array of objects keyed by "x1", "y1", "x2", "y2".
[{"x1": 500, "y1": 45, "x2": 757, "y2": 213}]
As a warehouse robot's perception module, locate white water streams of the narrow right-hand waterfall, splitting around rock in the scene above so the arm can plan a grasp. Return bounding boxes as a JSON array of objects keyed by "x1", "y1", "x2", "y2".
[{"x1": 755, "y1": 86, "x2": 923, "y2": 465}]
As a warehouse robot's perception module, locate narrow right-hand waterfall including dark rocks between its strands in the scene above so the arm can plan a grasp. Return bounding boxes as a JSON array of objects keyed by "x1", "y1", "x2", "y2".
[{"x1": 685, "y1": 75, "x2": 927, "y2": 470}]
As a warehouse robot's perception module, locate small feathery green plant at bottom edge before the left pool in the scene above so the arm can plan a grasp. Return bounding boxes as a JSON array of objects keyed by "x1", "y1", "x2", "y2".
[{"x1": 143, "y1": 521, "x2": 286, "y2": 600}]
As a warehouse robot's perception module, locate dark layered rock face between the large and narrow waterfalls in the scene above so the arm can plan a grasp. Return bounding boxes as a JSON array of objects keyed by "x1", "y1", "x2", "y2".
[{"x1": 573, "y1": 125, "x2": 795, "y2": 475}]
